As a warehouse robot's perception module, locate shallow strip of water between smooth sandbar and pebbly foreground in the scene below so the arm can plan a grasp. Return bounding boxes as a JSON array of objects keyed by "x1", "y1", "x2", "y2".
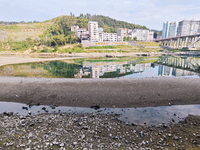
[{"x1": 0, "y1": 102, "x2": 200, "y2": 126}]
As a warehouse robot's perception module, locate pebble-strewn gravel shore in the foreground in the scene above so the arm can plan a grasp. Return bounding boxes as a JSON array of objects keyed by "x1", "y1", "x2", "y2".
[{"x1": 0, "y1": 112, "x2": 200, "y2": 150}]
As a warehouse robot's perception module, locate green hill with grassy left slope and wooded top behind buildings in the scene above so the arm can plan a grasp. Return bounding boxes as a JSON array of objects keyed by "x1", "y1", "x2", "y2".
[{"x1": 0, "y1": 14, "x2": 148, "y2": 51}]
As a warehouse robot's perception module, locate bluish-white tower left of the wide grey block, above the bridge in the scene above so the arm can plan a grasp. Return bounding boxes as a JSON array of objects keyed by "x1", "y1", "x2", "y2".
[{"x1": 162, "y1": 21, "x2": 178, "y2": 38}]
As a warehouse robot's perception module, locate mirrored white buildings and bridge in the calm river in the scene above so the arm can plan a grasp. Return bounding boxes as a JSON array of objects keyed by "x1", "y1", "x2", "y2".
[{"x1": 75, "y1": 57, "x2": 200, "y2": 78}]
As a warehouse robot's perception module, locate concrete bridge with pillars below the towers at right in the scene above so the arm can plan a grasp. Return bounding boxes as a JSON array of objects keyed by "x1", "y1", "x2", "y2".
[{"x1": 155, "y1": 34, "x2": 200, "y2": 49}]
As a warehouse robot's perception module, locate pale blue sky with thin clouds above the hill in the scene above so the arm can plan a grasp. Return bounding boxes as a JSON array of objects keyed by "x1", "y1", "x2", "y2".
[{"x1": 0, "y1": 0, "x2": 200, "y2": 30}]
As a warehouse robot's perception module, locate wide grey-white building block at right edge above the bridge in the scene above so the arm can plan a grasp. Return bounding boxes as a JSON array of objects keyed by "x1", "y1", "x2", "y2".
[{"x1": 177, "y1": 20, "x2": 200, "y2": 36}]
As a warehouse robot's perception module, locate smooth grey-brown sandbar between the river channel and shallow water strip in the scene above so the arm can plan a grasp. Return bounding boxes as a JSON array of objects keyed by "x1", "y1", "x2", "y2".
[{"x1": 0, "y1": 76, "x2": 200, "y2": 108}]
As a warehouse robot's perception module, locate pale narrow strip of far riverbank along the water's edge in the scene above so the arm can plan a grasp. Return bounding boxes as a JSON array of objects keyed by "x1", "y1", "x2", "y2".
[{"x1": 0, "y1": 52, "x2": 200, "y2": 66}]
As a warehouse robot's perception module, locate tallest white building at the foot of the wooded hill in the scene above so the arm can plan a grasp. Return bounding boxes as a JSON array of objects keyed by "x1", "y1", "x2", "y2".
[{"x1": 88, "y1": 21, "x2": 99, "y2": 42}]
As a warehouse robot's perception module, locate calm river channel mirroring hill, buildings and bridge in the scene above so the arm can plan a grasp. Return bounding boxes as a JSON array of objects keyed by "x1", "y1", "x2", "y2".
[{"x1": 0, "y1": 57, "x2": 200, "y2": 78}]
